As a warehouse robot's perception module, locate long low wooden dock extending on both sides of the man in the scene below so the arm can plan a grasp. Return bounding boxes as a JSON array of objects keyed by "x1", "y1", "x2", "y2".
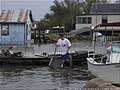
[{"x1": 0, "y1": 51, "x2": 92, "y2": 64}]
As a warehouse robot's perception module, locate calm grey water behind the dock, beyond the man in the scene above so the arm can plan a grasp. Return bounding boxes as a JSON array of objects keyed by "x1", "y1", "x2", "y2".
[{"x1": 34, "y1": 41, "x2": 105, "y2": 54}]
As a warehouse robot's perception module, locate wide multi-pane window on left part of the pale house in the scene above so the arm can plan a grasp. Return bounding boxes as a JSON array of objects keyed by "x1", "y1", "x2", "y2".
[{"x1": 77, "y1": 17, "x2": 92, "y2": 24}]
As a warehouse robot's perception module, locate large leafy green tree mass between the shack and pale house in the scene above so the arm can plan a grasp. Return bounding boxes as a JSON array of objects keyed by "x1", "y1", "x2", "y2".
[{"x1": 39, "y1": 0, "x2": 96, "y2": 31}]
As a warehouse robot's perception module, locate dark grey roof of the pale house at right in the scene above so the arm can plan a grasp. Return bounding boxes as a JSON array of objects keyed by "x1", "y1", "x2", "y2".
[{"x1": 90, "y1": 3, "x2": 120, "y2": 15}]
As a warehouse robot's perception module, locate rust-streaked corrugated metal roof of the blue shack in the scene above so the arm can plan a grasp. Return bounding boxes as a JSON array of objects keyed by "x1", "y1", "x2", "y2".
[{"x1": 0, "y1": 10, "x2": 29, "y2": 23}]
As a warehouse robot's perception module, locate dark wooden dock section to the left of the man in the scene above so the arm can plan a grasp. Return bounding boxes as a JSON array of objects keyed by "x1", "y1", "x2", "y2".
[{"x1": 0, "y1": 56, "x2": 50, "y2": 64}]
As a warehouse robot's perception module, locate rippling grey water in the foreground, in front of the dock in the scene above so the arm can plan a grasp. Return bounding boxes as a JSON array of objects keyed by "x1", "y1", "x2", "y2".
[{"x1": 0, "y1": 65, "x2": 86, "y2": 90}]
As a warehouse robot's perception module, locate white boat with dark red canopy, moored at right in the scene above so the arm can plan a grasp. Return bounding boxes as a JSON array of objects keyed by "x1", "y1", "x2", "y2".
[{"x1": 87, "y1": 22, "x2": 120, "y2": 84}]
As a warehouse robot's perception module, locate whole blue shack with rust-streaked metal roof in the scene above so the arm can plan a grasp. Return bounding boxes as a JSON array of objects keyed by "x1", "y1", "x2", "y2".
[{"x1": 0, "y1": 10, "x2": 33, "y2": 46}]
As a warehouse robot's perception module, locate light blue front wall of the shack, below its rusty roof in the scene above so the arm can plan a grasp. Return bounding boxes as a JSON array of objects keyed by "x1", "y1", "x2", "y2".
[{"x1": 0, "y1": 24, "x2": 25, "y2": 46}]
